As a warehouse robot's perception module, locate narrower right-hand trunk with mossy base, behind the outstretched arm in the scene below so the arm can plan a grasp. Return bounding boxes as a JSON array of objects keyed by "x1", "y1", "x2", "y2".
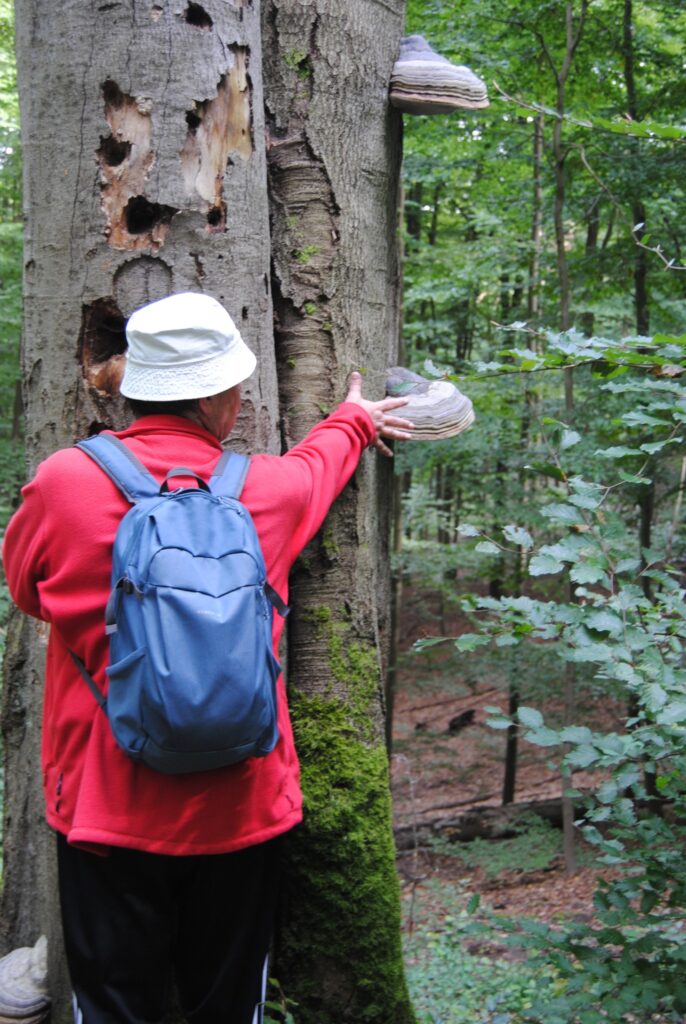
[{"x1": 263, "y1": 0, "x2": 412, "y2": 1024}]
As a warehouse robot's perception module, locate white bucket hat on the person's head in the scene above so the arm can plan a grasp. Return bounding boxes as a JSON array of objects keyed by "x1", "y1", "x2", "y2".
[{"x1": 120, "y1": 292, "x2": 257, "y2": 401}]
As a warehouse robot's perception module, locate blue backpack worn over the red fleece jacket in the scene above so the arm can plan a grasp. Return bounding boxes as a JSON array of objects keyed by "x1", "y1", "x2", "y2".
[{"x1": 71, "y1": 434, "x2": 288, "y2": 774}]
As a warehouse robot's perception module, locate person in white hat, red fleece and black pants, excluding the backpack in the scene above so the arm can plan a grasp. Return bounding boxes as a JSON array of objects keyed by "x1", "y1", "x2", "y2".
[{"x1": 3, "y1": 293, "x2": 412, "y2": 1024}]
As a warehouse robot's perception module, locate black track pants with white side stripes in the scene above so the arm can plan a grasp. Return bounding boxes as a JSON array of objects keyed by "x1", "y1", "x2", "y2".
[{"x1": 57, "y1": 836, "x2": 281, "y2": 1024}]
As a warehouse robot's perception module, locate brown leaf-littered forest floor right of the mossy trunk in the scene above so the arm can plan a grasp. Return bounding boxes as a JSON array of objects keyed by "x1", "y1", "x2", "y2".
[{"x1": 392, "y1": 594, "x2": 621, "y2": 937}]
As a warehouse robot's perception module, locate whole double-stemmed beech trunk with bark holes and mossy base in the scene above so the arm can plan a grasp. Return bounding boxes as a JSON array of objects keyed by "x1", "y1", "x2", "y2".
[{"x1": 0, "y1": 0, "x2": 412, "y2": 1024}]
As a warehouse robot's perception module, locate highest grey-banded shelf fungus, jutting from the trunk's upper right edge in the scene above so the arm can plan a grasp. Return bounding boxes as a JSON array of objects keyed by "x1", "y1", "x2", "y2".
[{"x1": 390, "y1": 36, "x2": 488, "y2": 114}]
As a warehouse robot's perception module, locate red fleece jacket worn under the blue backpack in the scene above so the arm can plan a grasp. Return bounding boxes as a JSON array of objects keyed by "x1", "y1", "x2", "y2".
[{"x1": 3, "y1": 403, "x2": 375, "y2": 855}]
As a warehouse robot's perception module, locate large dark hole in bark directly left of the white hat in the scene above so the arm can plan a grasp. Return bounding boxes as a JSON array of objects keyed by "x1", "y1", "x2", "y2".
[{"x1": 79, "y1": 298, "x2": 126, "y2": 395}]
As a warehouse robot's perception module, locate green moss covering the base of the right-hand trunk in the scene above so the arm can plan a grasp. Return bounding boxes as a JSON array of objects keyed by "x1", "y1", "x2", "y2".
[{"x1": 277, "y1": 606, "x2": 414, "y2": 1024}]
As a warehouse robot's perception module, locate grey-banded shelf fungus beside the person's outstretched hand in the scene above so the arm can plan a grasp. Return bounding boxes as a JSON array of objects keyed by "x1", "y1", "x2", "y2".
[{"x1": 386, "y1": 367, "x2": 474, "y2": 441}]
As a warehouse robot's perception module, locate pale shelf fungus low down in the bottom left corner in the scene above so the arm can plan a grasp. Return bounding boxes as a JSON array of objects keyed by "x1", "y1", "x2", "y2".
[{"x1": 0, "y1": 935, "x2": 50, "y2": 1024}]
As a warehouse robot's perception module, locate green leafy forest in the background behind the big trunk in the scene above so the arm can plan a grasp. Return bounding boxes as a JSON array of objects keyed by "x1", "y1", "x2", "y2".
[{"x1": 0, "y1": 0, "x2": 686, "y2": 1024}]
